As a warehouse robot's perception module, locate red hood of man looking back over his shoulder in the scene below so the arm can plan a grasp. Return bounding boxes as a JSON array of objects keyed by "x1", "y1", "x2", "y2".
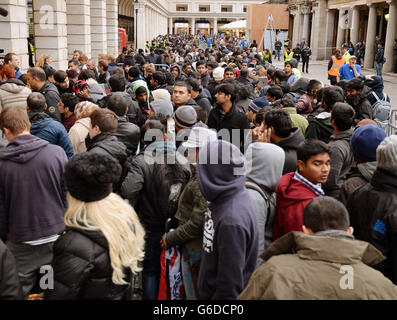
[{"x1": 277, "y1": 172, "x2": 317, "y2": 206}]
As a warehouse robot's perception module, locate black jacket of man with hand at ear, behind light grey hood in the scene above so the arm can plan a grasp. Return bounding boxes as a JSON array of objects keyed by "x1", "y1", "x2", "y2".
[{"x1": 277, "y1": 128, "x2": 305, "y2": 174}]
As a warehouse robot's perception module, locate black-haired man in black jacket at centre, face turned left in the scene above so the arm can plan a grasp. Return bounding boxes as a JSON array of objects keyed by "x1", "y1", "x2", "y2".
[{"x1": 207, "y1": 83, "x2": 250, "y2": 150}]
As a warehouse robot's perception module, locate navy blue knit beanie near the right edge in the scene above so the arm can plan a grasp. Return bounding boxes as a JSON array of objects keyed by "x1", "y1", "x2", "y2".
[{"x1": 350, "y1": 124, "x2": 386, "y2": 162}]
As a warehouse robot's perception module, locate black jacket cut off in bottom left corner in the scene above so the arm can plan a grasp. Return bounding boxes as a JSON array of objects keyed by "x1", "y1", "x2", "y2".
[{"x1": 0, "y1": 240, "x2": 23, "y2": 300}]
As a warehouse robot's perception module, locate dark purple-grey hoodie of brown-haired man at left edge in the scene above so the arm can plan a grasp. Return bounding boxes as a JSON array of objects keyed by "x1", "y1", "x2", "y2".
[{"x1": 0, "y1": 135, "x2": 67, "y2": 243}]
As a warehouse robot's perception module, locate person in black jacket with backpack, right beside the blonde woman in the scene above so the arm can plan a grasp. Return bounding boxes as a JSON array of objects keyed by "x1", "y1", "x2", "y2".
[{"x1": 121, "y1": 120, "x2": 190, "y2": 300}]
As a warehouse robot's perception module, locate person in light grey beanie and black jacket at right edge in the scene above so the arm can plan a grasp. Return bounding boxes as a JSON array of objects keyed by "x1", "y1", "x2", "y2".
[{"x1": 346, "y1": 134, "x2": 397, "y2": 284}]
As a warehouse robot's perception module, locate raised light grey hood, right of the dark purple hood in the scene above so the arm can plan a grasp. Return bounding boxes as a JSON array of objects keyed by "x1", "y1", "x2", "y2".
[{"x1": 245, "y1": 142, "x2": 285, "y2": 191}]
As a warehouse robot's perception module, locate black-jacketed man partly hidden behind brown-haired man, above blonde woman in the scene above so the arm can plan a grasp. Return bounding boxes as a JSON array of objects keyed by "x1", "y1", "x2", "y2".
[{"x1": 108, "y1": 95, "x2": 141, "y2": 156}]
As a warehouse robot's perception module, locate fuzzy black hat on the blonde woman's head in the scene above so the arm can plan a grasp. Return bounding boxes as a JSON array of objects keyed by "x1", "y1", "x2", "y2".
[{"x1": 64, "y1": 152, "x2": 121, "y2": 202}]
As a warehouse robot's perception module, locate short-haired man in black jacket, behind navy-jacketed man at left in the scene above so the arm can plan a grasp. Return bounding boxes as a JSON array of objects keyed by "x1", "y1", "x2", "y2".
[{"x1": 27, "y1": 67, "x2": 62, "y2": 122}]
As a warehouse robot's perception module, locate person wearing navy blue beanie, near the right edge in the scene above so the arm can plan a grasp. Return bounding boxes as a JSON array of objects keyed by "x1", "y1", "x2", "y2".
[{"x1": 339, "y1": 124, "x2": 386, "y2": 205}]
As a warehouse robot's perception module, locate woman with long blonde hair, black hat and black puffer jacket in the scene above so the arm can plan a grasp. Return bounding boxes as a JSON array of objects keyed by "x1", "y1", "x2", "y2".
[{"x1": 45, "y1": 153, "x2": 145, "y2": 300}]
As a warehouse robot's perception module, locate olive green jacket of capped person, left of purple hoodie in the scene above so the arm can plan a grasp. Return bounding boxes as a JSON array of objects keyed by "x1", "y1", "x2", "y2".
[{"x1": 166, "y1": 165, "x2": 208, "y2": 249}]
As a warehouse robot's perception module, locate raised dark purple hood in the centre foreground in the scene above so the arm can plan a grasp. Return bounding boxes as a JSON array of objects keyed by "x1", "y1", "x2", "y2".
[{"x1": 197, "y1": 140, "x2": 246, "y2": 202}]
